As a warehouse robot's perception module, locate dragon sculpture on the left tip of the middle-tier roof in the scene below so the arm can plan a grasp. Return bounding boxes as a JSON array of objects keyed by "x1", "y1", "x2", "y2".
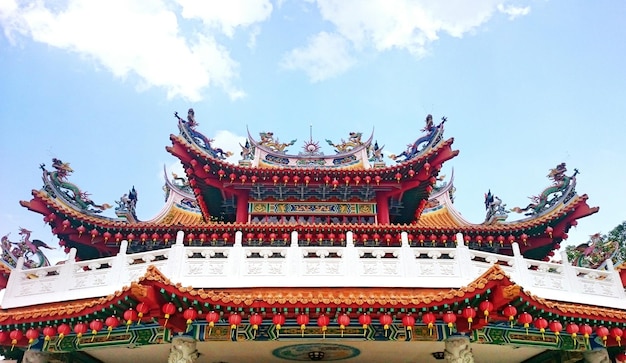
[{"x1": 39, "y1": 158, "x2": 111, "y2": 213}]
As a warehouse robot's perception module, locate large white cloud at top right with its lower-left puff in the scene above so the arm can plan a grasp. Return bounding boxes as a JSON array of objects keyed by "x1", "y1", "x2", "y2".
[{"x1": 284, "y1": 0, "x2": 530, "y2": 81}]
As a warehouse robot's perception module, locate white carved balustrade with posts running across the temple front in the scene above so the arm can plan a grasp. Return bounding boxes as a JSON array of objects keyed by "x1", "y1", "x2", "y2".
[{"x1": 2, "y1": 232, "x2": 626, "y2": 308}]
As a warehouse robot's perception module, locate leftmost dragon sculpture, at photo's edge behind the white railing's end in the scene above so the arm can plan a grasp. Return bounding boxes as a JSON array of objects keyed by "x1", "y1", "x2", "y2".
[{"x1": 1, "y1": 227, "x2": 54, "y2": 268}]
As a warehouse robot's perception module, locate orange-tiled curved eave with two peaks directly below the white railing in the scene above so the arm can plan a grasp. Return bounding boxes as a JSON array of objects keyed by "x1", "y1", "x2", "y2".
[{"x1": 0, "y1": 265, "x2": 626, "y2": 329}]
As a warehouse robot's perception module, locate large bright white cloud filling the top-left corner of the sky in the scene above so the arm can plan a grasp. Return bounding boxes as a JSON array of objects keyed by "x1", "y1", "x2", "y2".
[{"x1": 0, "y1": 0, "x2": 272, "y2": 101}]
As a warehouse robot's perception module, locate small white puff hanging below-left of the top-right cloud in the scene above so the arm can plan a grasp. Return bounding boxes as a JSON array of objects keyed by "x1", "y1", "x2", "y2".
[{"x1": 281, "y1": 32, "x2": 355, "y2": 82}]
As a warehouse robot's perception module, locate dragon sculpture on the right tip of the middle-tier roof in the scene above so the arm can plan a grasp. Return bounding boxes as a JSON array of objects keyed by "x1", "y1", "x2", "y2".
[{"x1": 511, "y1": 163, "x2": 578, "y2": 216}]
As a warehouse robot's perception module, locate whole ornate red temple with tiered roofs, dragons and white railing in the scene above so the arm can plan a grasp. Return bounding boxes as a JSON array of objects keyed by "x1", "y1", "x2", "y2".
[{"x1": 0, "y1": 109, "x2": 626, "y2": 363}]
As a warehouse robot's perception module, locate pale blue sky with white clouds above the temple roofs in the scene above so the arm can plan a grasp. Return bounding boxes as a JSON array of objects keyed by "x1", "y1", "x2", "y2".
[{"x1": 0, "y1": 0, "x2": 626, "y2": 264}]
